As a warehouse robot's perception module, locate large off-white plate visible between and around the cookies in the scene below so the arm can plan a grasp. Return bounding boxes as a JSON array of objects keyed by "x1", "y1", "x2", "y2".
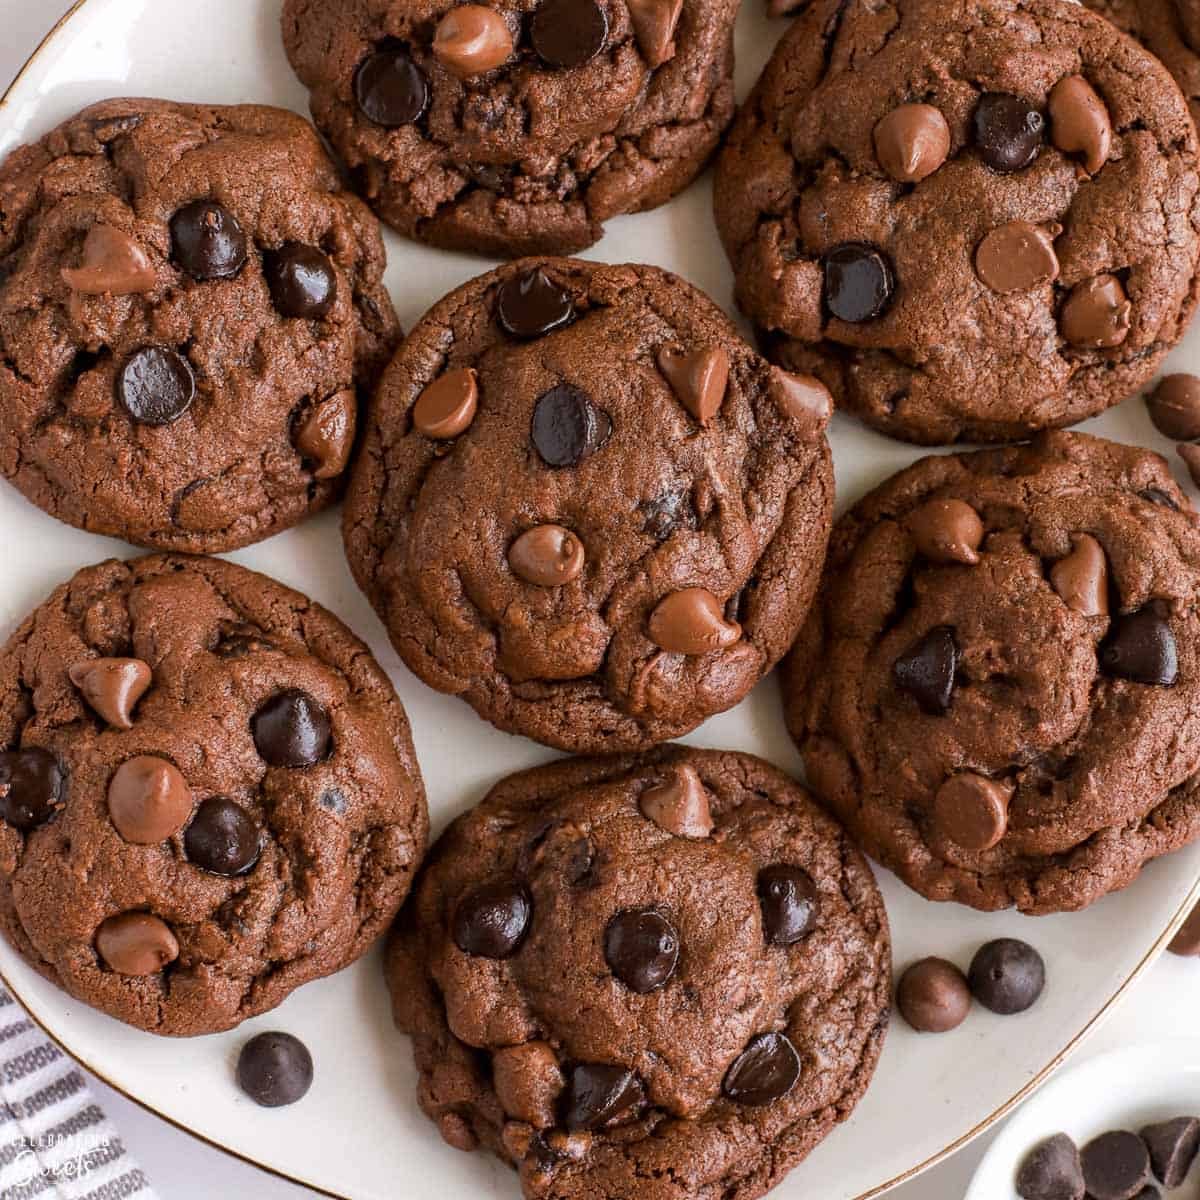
[{"x1": 0, "y1": 0, "x2": 1200, "y2": 1200}]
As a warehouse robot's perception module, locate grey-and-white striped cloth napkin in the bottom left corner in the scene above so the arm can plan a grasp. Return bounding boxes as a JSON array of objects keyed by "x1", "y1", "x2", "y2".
[{"x1": 0, "y1": 986, "x2": 155, "y2": 1200}]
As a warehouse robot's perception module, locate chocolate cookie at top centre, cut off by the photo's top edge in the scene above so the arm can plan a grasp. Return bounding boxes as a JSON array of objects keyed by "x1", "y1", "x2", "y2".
[{"x1": 283, "y1": 0, "x2": 738, "y2": 257}]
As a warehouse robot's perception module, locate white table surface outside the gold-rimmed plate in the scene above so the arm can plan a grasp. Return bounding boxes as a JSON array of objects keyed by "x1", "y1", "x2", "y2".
[{"x1": 0, "y1": 0, "x2": 1200, "y2": 1200}]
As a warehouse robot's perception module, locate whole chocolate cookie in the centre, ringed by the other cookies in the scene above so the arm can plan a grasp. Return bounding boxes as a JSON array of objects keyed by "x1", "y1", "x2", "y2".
[{"x1": 344, "y1": 259, "x2": 833, "y2": 752}]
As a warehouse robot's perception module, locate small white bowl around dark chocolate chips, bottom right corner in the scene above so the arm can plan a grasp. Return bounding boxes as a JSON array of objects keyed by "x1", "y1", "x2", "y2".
[{"x1": 964, "y1": 1038, "x2": 1200, "y2": 1200}]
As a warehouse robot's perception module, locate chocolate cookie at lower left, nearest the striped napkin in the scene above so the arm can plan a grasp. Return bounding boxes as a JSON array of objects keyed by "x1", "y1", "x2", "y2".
[{"x1": 0, "y1": 557, "x2": 428, "y2": 1034}]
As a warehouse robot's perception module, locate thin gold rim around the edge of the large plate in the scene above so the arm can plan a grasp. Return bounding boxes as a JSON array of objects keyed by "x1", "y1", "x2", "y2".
[{"x1": 7, "y1": 0, "x2": 1200, "y2": 1200}]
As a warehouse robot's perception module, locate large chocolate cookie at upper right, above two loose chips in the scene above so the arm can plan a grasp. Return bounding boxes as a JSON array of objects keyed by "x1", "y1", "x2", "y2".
[{"x1": 716, "y1": 0, "x2": 1200, "y2": 444}]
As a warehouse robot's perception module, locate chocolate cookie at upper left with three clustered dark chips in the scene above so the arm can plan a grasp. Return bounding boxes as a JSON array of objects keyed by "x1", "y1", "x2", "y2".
[{"x1": 0, "y1": 100, "x2": 400, "y2": 552}]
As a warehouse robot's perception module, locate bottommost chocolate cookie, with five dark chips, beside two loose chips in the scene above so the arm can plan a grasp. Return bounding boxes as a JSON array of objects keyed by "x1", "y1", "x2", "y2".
[{"x1": 388, "y1": 746, "x2": 890, "y2": 1200}]
